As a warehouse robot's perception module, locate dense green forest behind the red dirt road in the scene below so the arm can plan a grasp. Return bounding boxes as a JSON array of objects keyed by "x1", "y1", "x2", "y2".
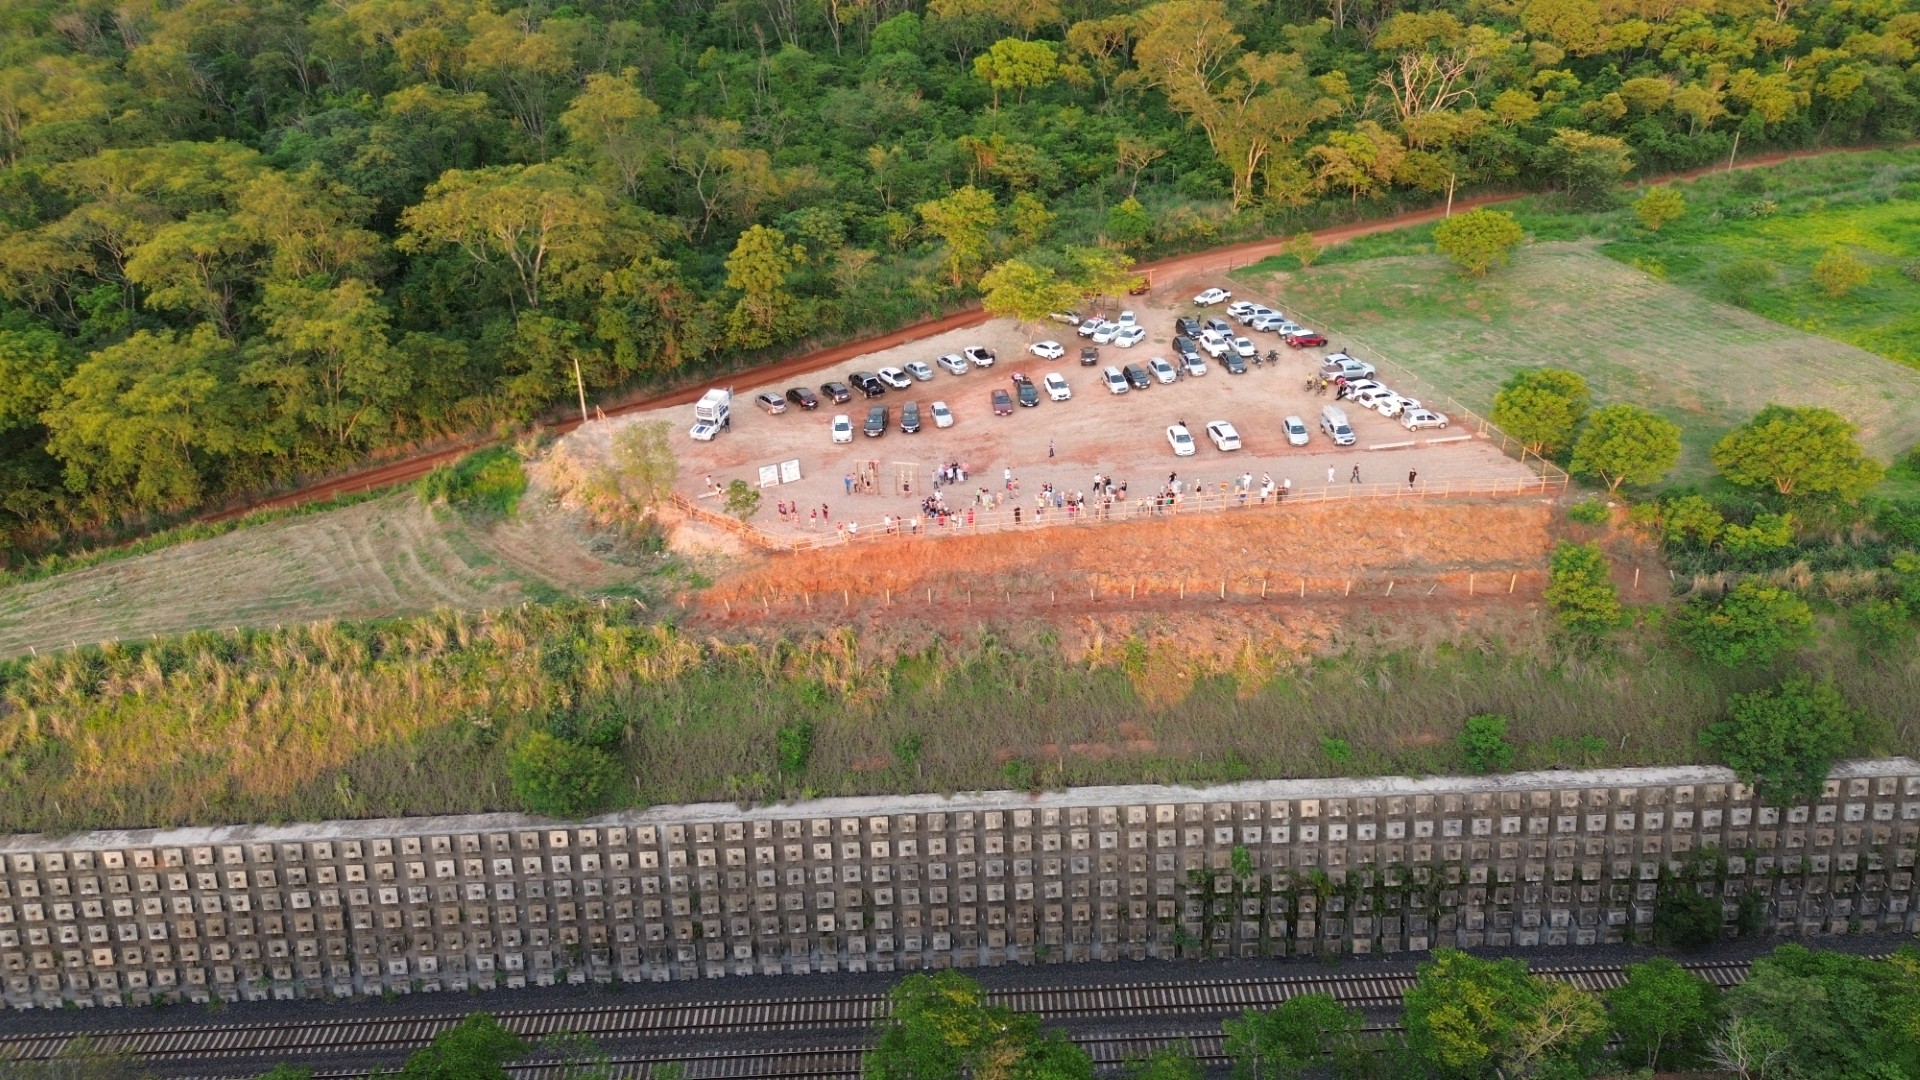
[{"x1": 0, "y1": 0, "x2": 1920, "y2": 553}]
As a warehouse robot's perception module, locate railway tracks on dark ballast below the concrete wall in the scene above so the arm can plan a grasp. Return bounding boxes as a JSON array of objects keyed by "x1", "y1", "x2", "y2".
[{"x1": 0, "y1": 961, "x2": 1747, "y2": 1078}]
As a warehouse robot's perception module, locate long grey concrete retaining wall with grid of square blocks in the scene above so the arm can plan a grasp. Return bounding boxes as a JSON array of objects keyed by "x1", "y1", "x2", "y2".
[{"x1": 0, "y1": 759, "x2": 1920, "y2": 1007}]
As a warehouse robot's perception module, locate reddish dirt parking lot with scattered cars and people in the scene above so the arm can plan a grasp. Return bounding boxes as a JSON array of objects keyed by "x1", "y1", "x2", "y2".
[{"x1": 568, "y1": 282, "x2": 1532, "y2": 532}]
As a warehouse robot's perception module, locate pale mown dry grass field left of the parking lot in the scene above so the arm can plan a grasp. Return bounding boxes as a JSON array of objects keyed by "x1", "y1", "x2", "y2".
[{"x1": 0, "y1": 492, "x2": 637, "y2": 657}]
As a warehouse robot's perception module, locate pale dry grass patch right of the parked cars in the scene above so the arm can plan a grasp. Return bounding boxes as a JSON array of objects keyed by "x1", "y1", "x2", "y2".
[{"x1": 1238, "y1": 242, "x2": 1920, "y2": 480}]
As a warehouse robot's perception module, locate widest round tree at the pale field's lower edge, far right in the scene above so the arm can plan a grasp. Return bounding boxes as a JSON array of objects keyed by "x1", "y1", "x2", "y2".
[{"x1": 1720, "y1": 405, "x2": 1885, "y2": 502}]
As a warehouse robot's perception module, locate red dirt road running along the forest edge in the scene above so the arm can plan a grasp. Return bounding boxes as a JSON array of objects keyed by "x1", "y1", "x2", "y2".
[{"x1": 196, "y1": 146, "x2": 1887, "y2": 521}]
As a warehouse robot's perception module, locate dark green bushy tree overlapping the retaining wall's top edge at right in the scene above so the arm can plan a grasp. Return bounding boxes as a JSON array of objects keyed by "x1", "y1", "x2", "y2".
[{"x1": 1701, "y1": 675, "x2": 1860, "y2": 805}]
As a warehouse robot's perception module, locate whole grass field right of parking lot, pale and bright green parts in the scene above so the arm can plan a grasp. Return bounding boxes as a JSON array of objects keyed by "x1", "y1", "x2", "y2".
[{"x1": 1233, "y1": 150, "x2": 1920, "y2": 486}]
